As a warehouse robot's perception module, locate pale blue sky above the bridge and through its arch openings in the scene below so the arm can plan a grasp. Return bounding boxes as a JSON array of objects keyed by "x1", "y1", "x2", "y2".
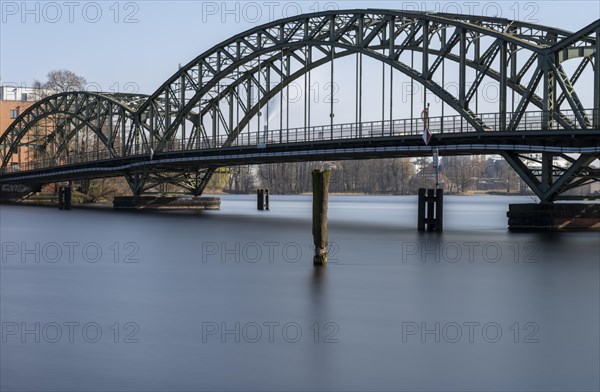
[{"x1": 0, "y1": 0, "x2": 600, "y2": 126}]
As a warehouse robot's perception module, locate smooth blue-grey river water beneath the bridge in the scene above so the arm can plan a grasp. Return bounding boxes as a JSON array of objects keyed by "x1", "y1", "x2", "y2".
[{"x1": 0, "y1": 196, "x2": 600, "y2": 391}]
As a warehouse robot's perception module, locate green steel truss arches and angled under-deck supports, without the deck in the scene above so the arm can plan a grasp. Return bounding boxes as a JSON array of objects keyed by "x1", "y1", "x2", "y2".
[{"x1": 0, "y1": 10, "x2": 600, "y2": 201}]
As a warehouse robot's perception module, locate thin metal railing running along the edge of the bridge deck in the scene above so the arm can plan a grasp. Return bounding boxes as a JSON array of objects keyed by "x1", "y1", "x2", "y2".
[{"x1": 3, "y1": 110, "x2": 600, "y2": 173}]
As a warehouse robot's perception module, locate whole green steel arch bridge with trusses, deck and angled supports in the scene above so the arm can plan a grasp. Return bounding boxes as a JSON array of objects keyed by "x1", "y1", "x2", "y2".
[{"x1": 0, "y1": 9, "x2": 600, "y2": 201}]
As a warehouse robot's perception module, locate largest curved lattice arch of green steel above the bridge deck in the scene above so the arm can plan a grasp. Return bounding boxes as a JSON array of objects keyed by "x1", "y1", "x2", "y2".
[{"x1": 140, "y1": 10, "x2": 600, "y2": 155}]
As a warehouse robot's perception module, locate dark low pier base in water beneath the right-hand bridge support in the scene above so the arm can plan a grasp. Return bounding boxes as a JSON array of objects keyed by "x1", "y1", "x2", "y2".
[{"x1": 506, "y1": 203, "x2": 600, "y2": 231}]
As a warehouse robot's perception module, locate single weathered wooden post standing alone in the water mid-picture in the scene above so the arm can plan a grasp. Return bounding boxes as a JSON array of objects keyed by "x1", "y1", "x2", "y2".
[{"x1": 312, "y1": 170, "x2": 331, "y2": 266}]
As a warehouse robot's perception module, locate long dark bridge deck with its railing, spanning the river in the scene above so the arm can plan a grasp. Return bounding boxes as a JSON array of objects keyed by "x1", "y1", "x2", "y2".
[{"x1": 0, "y1": 112, "x2": 600, "y2": 183}]
